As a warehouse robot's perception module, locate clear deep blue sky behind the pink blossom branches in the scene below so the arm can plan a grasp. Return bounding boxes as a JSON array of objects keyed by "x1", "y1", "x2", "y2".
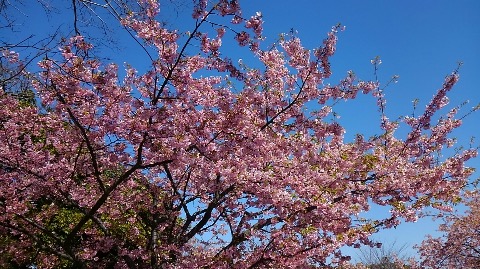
[{"x1": 0, "y1": 0, "x2": 480, "y2": 260}]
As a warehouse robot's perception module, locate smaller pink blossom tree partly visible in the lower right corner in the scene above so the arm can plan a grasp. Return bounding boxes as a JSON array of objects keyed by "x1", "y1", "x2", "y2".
[{"x1": 418, "y1": 188, "x2": 480, "y2": 268}]
